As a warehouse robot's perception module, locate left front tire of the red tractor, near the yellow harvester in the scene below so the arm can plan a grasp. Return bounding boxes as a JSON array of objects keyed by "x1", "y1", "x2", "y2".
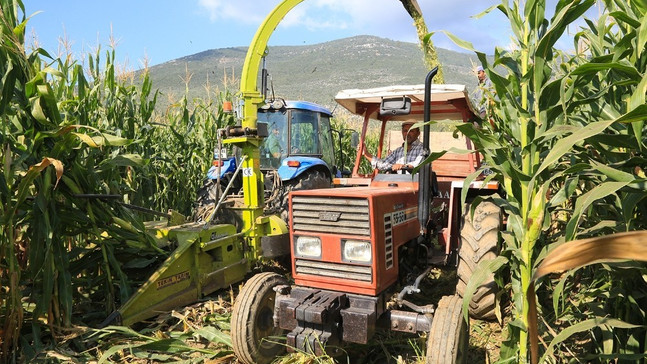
[{"x1": 231, "y1": 272, "x2": 287, "y2": 364}]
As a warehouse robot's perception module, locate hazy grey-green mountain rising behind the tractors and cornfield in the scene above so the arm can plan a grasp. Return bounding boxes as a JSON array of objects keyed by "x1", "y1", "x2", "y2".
[{"x1": 144, "y1": 36, "x2": 484, "y2": 108}]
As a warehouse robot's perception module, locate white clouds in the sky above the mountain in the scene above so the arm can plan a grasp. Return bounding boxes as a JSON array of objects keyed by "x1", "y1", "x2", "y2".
[{"x1": 198, "y1": 0, "x2": 604, "y2": 53}]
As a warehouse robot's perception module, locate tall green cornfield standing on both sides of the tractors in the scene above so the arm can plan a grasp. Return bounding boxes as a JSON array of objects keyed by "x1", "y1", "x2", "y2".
[{"x1": 0, "y1": 0, "x2": 647, "y2": 363}]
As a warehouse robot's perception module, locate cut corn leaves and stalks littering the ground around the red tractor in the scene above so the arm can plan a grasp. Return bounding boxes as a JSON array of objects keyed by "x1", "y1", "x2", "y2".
[{"x1": 24, "y1": 265, "x2": 505, "y2": 364}]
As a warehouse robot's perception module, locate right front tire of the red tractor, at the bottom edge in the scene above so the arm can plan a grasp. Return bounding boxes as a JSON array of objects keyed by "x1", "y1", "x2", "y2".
[{"x1": 425, "y1": 295, "x2": 470, "y2": 364}]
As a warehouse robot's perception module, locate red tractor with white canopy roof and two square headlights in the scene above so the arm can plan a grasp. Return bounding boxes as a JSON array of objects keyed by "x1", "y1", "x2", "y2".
[{"x1": 231, "y1": 71, "x2": 501, "y2": 364}]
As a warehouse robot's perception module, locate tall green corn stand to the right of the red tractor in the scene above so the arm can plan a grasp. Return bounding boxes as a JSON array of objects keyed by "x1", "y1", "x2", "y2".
[{"x1": 436, "y1": 0, "x2": 647, "y2": 363}]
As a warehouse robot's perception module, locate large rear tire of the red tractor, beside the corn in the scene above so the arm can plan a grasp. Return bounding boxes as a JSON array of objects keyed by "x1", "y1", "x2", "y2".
[{"x1": 456, "y1": 201, "x2": 502, "y2": 320}]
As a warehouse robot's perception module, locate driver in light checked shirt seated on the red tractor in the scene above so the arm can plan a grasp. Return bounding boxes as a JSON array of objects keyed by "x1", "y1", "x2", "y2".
[{"x1": 362, "y1": 121, "x2": 427, "y2": 173}]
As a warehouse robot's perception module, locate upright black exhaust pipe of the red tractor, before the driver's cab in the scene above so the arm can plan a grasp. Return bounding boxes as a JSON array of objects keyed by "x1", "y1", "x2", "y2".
[{"x1": 418, "y1": 66, "x2": 438, "y2": 236}]
